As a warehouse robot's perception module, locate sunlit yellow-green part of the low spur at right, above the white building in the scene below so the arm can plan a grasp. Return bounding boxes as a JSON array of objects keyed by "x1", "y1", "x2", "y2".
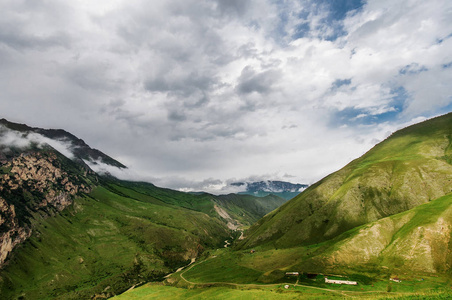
[{"x1": 292, "y1": 194, "x2": 452, "y2": 276}]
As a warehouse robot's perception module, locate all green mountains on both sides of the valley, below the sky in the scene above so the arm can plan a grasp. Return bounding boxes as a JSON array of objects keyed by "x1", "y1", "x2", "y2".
[{"x1": 0, "y1": 113, "x2": 452, "y2": 299}]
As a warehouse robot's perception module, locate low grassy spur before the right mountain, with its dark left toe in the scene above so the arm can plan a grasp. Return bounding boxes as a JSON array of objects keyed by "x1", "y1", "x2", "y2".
[{"x1": 182, "y1": 195, "x2": 452, "y2": 283}]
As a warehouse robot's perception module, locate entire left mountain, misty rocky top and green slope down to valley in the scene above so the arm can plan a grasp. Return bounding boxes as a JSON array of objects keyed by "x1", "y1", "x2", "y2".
[{"x1": 0, "y1": 119, "x2": 285, "y2": 299}]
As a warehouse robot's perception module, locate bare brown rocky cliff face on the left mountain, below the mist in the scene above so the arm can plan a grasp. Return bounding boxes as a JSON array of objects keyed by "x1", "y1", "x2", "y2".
[{"x1": 0, "y1": 152, "x2": 92, "y2": 267}]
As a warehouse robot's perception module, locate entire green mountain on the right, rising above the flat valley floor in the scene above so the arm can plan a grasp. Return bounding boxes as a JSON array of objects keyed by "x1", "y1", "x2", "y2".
[{"x1": 203, "y1": 114, "x2": 452, "y2": 284}]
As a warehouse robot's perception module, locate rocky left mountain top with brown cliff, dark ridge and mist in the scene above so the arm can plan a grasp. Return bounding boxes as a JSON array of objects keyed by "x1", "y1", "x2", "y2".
[{"x1": 0, "y1": 119, "x2": 125, "y2": 267}]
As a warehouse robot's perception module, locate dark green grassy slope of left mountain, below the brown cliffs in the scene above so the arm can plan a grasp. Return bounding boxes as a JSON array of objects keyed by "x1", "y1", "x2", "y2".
[{"x1": 0, "y1": 187, "x2": 229, "y2": 299}]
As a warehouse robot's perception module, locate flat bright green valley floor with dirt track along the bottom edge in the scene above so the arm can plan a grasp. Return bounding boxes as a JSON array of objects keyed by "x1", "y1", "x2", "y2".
[{"x1": 113, "y1": 251, "x2": 452, "y2": 300}]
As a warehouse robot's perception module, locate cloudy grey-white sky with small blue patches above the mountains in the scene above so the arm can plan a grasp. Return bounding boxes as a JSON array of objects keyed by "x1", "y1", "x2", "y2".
[{"x1": 0, "y1": 0, "x2": 452, "y2": 189}]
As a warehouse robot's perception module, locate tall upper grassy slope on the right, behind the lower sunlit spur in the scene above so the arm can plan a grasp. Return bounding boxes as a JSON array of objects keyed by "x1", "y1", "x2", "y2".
[{"x1": 242, "y1": 114, "x2": 452, "y2": 248}]
